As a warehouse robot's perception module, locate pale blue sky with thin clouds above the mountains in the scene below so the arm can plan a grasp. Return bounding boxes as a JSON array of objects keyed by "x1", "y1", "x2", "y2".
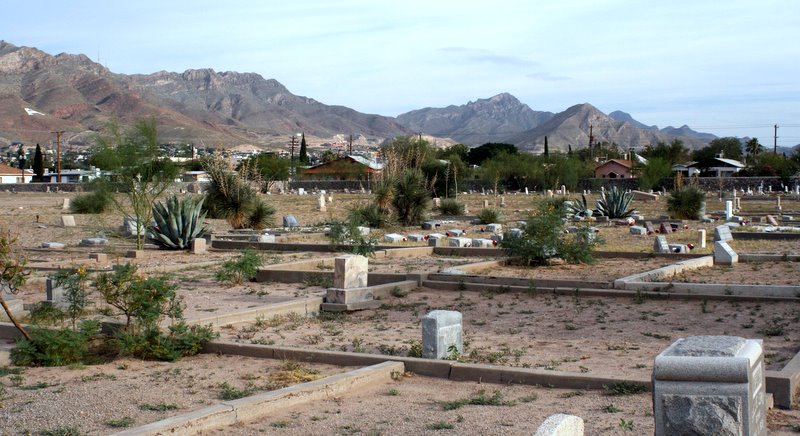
[{"x1": 0, "y1": 0, "x2": 800, "y2": 146}]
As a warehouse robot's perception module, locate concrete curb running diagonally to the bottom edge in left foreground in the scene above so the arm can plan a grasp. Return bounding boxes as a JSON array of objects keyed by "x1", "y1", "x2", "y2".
[{"x1": 109, "y1": 362, "x2": 405, "y2": 436}]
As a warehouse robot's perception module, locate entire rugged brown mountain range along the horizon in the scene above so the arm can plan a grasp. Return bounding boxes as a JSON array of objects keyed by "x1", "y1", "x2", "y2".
[{"x1": 0, "y1": 41, "x2": 714, "y2": 152}]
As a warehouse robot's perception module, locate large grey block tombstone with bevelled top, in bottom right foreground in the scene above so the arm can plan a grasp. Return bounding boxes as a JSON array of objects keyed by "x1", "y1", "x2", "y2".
[{"x1": 653, "y1": 336, "x2": 767, "y2": 436}]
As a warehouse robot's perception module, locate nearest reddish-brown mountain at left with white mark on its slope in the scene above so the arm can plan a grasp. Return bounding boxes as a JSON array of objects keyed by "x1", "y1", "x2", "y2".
[{"x1": 0, "y1": 41, "x2": 413, "y2": 146}]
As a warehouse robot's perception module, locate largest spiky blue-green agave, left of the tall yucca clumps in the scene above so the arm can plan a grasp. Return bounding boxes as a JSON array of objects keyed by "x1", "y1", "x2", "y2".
[{"x1": 150, "y1": 195, "x2": 208, "y2": 250}]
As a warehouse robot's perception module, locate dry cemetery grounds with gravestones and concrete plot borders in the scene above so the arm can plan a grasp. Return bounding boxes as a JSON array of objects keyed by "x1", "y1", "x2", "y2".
[{"x1": 0, "y1": 191, "x2": 800, "y2": 434}]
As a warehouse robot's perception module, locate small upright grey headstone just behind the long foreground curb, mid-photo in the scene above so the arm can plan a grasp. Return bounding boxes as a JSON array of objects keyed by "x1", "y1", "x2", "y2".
[{"x1": 422, "y1": 310, "x2": 464, "y2": 359}]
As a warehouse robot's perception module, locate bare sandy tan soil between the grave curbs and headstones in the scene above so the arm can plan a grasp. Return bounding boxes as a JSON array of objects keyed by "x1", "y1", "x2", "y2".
[{"x1": 0, "y1": 192, "x2": 800, "y2": 434}]
